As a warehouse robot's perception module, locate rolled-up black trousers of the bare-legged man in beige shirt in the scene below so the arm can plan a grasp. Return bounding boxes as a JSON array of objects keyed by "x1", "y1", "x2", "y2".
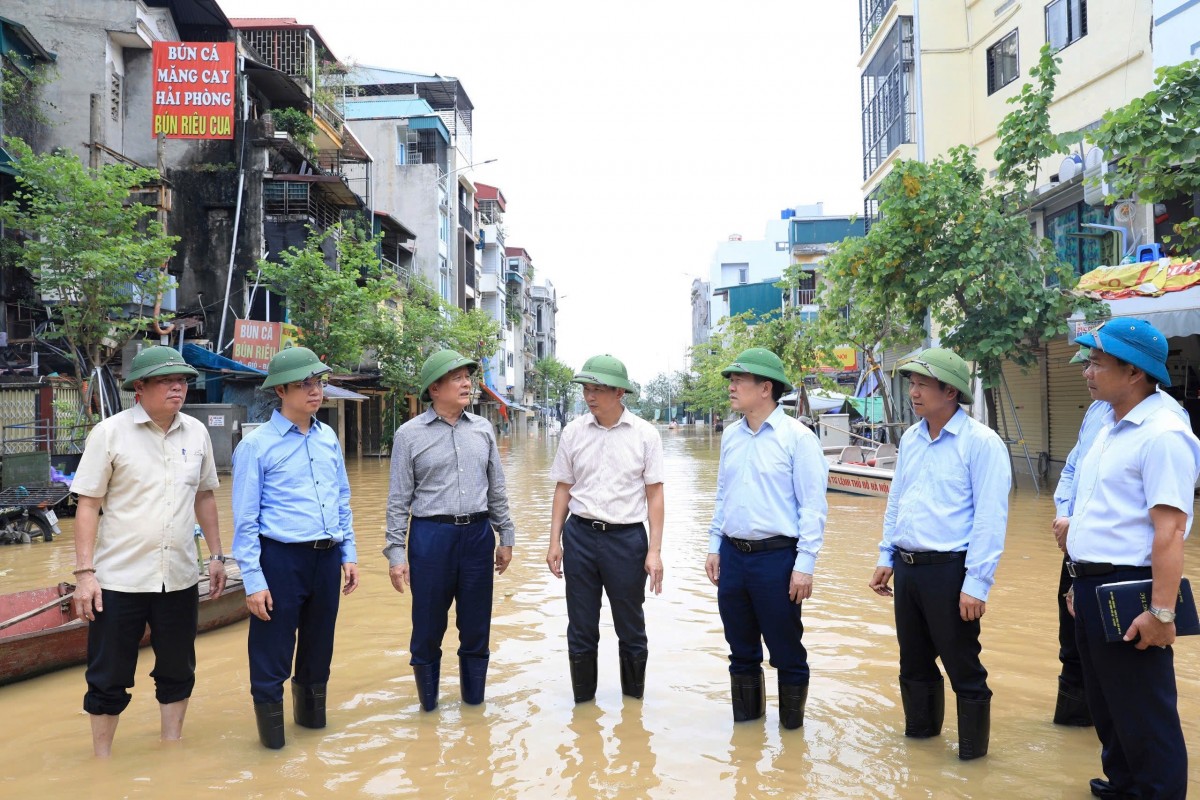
[{"x1": 83, "y1": 587, "x2": 200, "y2": 715}]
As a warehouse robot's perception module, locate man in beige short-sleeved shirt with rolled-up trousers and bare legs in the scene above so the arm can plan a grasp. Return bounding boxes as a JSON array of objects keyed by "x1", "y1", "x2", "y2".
[{"x1": 71, "y1": 347, "x2": 226, "y2": 758}]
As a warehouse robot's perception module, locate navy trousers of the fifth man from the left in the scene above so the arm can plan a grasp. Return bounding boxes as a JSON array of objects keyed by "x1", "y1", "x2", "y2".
[{"x1": 716, "y1": 539, "x2": 809, "y2": 685}]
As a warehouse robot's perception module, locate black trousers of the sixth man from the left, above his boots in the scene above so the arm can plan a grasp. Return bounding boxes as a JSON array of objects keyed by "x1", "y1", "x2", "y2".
[{"x1": 894, "y1": 553, "x2": 991, "y2": 700}]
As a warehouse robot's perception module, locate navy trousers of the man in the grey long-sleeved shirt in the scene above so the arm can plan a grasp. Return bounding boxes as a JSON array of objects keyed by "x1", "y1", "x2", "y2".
[{"x1": 408, "y1": 518, "x2": 496, "y2": 667}]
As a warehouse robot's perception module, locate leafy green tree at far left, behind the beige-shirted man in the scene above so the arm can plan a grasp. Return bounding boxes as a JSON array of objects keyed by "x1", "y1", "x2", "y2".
[{"x1": 0, "y1": 138, "x2": 179, "y2": 409}]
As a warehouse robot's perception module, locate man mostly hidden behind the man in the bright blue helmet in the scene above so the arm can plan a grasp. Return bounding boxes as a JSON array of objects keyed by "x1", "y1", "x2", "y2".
[{"x1": 1052, "y1": 348, "x2": 1190, "y2": 728}]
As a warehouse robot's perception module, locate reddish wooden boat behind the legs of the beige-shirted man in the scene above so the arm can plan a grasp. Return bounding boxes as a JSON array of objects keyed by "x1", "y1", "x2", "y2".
[{"x1": 0, "y1": 576, "x2": 250, "y2": 686}]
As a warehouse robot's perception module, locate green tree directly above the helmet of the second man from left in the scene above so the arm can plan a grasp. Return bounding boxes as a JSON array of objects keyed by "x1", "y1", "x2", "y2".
[{"x1": 258, "y1": 223, "x2": 397, "y2": 369}]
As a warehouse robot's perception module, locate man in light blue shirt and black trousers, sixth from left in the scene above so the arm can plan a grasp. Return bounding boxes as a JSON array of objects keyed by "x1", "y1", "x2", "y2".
[{"x1": 869, "y1": 348, "x2": 1012, "y2": 760}]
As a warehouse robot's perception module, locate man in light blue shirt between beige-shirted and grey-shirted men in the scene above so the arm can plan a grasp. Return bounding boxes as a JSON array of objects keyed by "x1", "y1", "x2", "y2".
[{"x1": 233, "y1": 348, "x2": 359, "y2": 750}]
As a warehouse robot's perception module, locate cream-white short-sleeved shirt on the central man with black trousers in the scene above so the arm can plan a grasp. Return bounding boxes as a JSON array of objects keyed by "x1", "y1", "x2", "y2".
[{"x1": 550, "y1": 409, "x2": 662, "y2": 524}]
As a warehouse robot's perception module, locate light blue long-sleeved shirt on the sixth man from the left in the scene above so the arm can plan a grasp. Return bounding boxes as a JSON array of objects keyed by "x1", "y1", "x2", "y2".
[{"x1": 878, "y1": 408, "x2": 1013, "y2": 601}]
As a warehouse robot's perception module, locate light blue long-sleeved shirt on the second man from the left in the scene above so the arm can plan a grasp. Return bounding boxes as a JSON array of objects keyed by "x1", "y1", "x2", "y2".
[{"x1": 233, "y1": 409, "x2": 358, "y2": 595}]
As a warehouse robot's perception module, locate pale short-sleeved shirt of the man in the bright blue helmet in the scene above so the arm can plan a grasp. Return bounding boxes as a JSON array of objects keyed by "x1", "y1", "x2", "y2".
[{"x1": 1067, "y1": 392, "x2": 1200, "y2": 566}]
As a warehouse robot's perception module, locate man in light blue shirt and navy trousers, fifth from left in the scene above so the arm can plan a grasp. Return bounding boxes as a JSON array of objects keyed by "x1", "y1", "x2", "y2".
[{"x1": 704, "y1": 348, "x2": 829, "y2": 729}]
